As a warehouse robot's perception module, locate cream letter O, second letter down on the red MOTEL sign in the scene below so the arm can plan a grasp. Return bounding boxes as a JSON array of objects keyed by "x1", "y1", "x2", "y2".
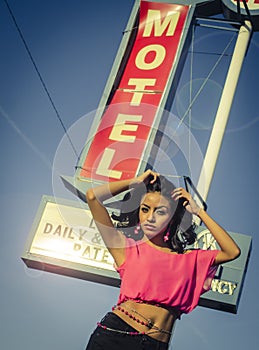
[{"x1": 135, "y1": 45, "x2": 166, "y2": 70}]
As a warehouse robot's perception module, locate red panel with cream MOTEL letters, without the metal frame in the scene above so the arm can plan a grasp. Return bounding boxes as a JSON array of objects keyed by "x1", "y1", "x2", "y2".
[{"x1": 80, "y1": 1, "x2": 189, "y2": 182}]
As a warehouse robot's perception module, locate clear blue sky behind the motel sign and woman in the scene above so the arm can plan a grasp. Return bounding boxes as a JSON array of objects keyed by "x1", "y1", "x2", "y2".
[{"x1": 0, "y1": 0, "x2": 259, "y2": 350}]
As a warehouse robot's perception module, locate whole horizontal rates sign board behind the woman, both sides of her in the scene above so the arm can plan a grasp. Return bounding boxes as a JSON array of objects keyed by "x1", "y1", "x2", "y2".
[{"x1": 22, "y1": 196, "x2": 252, "y2": 313}]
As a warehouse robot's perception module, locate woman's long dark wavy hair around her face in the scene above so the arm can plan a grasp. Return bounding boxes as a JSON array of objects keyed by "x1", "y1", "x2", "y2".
[{"x1": 112, "y1": 175, "x2": 196, "y2": 253}]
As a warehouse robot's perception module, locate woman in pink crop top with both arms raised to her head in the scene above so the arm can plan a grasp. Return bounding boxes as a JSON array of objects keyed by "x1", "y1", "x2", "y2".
[{"x1": 86, "y1": 170, "x2": 240, "y2": 350}]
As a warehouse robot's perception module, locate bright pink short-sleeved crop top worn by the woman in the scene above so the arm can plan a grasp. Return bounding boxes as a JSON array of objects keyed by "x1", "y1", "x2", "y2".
[{"x1": 117, "y1": 239, "x2": 219, "y2": 313}]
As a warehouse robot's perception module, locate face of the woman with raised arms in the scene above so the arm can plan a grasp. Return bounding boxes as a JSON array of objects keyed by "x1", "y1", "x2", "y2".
[{"x1": 139, "y1": 192, "x2": 172, "y2": 239}]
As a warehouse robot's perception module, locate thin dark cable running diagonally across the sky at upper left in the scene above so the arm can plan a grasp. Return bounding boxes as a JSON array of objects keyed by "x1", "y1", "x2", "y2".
[{"x1": 3, "y1": 0, "x2": 79, "y2": 159}]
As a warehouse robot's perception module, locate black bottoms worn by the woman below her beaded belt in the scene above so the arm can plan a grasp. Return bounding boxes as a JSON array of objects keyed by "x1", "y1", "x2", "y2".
[{"x1": 86, "y1": 312, "x2": 171, "y2": 350}]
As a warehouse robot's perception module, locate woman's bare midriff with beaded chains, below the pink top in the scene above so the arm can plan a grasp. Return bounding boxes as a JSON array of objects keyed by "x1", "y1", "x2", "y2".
[{"x1": 113, "y1": 300, "x2": 179, "y2": 343}]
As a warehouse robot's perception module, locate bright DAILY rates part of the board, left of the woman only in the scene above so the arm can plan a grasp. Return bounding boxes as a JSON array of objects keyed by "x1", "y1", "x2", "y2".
[{"x1": 22, "y1": 196, "x2": 120, "y2": 286}]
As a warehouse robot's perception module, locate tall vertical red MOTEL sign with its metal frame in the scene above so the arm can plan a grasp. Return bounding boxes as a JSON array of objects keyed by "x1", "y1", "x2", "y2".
[{"x1": 63, "y1": 1, "x2": 195, "y2": 196}]
